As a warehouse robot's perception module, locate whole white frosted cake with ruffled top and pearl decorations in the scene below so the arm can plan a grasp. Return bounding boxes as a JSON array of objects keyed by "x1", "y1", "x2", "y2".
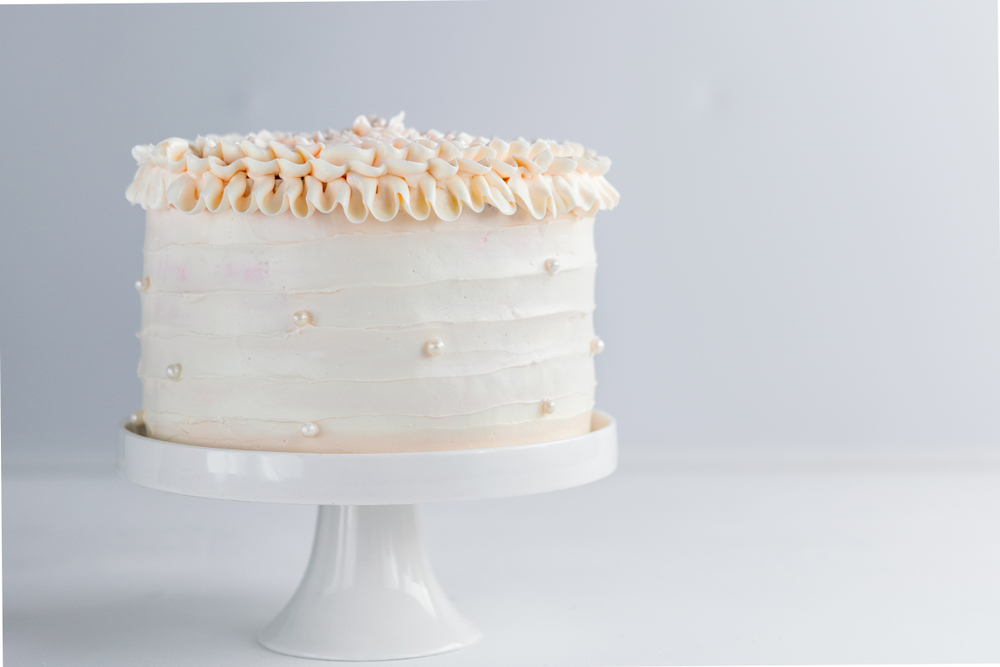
[{"x1": 126, "y1": 114, "x2": 618, "y2": 453}]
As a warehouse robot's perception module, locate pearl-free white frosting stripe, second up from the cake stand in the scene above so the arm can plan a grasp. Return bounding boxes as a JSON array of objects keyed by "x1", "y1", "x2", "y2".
[{"x1": 142, "y1": 354, "x2": 596, "y2": 421}]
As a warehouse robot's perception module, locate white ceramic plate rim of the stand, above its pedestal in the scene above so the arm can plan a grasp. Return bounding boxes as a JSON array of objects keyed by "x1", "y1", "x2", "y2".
[{"x1": 117, "y1": 410, "x2": 618, "y2": 505}]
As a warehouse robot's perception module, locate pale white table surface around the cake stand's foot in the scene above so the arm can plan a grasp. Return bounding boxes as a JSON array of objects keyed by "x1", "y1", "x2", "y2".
[{"x1": 3, "y1": 451, "x2": 1000, "y2": 667}]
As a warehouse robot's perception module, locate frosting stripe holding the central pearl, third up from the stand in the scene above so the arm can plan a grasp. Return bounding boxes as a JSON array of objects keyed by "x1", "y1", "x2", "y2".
[{"x1": 139, "y1": 314, "x2": 594, "y2": 381}]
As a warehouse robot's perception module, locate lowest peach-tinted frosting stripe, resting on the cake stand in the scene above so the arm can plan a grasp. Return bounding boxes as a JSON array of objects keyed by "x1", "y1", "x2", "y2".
[{"x1": 146, "y1": 411, "x2": 591, "y2": 452}]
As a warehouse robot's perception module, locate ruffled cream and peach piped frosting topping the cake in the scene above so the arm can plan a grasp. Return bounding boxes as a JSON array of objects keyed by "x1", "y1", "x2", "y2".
[{"x1": 125, "y1": 114, "x2": 618, "y2": 222}]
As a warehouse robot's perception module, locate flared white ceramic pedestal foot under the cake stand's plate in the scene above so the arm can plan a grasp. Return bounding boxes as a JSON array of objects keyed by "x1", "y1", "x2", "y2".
[{"x1": 259, "y1": 505, "x2": 481, "y2": 660}]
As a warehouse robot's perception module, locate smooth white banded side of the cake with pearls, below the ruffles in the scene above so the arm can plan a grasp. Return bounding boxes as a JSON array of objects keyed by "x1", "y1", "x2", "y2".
[{"x1": 139, "y1": 208, "x2": 601, "y2": 452}]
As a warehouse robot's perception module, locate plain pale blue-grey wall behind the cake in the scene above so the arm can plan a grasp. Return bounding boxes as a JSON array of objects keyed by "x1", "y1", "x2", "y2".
[{"x1": 0, "y1": 0, "x2": 1000, "y2": 465}]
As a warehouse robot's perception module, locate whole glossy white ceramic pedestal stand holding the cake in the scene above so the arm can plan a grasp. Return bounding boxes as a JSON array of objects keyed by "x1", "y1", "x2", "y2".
[{"x1": 118, "y1": 412, "x2": 618, "y2": 660}]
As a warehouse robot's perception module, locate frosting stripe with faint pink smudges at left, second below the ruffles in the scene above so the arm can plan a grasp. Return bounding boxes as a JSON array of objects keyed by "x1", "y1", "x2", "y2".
[{"x1": 145, "y1": 219, "x2": 597, "y2": 293}]
